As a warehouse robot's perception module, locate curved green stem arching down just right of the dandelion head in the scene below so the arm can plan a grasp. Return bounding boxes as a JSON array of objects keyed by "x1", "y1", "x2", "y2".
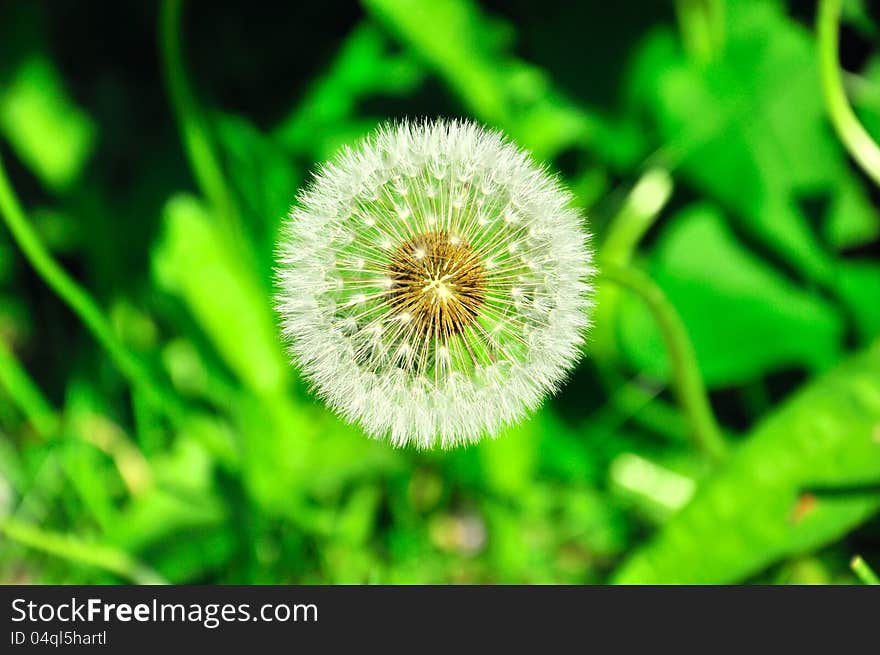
[{"x1": 602, "y1": 265, "x2": 728, "y2": 460}]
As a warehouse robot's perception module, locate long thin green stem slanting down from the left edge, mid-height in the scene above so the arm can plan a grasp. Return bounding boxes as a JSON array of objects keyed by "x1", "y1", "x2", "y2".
[{"x1": 0, "y1": 152, "x2": 180, "y2": 417}]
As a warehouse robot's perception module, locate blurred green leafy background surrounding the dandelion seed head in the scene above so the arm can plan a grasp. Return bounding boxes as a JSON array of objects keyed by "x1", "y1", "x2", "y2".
[{"x1": 0, "y1": 0, "x2": 880, "y2": 584}]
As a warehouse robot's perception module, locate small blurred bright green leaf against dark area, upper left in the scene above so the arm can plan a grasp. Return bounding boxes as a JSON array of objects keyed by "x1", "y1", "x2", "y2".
[{"x1": 0, "y1": 55, "x2": 97, "y2": 191}]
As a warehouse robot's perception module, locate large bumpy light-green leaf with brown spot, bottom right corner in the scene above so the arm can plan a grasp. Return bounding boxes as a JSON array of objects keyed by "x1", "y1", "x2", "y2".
[{"x1": 614, "y1": 344, "x2": 880, "y2": 584}]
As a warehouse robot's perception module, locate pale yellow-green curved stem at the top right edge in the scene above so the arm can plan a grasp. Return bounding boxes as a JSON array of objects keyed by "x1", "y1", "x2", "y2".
[{"x1": 816, "y1": 0, "x2": 880, "y2": 185}]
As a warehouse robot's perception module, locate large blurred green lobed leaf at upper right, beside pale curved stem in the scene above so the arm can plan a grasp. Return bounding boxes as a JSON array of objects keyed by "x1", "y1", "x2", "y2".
[{"x1": 631, "y1": 2, "x2": 880, "y2": 284}]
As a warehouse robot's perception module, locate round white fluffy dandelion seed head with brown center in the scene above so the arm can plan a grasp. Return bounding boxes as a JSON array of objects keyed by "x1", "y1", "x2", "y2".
[{"x1": 277, "y1": 121, "x2": 592, "y2": 448}]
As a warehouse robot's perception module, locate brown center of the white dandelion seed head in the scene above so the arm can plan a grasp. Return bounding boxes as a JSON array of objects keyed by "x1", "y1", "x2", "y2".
[{"x1": 388, "y1": 232, "x2": 486, "y2": 339}]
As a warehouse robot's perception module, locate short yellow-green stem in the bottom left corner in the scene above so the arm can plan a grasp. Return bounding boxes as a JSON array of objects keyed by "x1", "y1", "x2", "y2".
[{"x1": 0, "y1": 517, "x2": 167, "y2": 585}]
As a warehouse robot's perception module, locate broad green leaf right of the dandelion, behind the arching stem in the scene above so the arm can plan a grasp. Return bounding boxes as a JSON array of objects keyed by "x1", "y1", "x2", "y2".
[{"x1": 620, "y1": 204, "x2": 843, "y2": 386}]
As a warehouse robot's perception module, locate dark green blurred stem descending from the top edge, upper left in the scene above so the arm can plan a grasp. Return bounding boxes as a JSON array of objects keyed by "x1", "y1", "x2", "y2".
[{"x1": 159, "y1": 0, "x2": 241, "y2": 237}]
